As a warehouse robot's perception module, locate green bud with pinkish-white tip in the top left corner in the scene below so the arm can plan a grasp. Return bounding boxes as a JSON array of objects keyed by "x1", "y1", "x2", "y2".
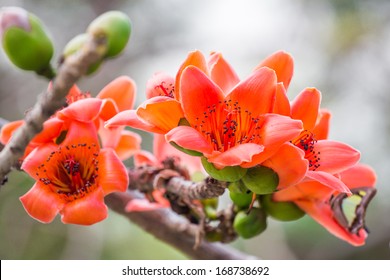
[{"x1": 0, "y1": 7, "x2": 54, "y2": 75}]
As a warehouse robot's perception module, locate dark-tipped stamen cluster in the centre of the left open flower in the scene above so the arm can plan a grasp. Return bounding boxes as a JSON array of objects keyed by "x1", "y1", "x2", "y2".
[{"x1": 36, "y1": 143, "x2": 99, "y2": 201}]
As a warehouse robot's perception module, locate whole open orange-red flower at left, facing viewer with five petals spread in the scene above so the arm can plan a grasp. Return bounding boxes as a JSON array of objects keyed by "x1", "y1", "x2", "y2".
[{"x1": 20, "y1": 121, "x2": 128, "y2": 225}]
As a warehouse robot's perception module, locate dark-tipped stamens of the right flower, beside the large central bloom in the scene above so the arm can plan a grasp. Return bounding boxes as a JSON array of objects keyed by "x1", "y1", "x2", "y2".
[{"x1": 291, "y1": 130, "x2": 321, "y2": 171}]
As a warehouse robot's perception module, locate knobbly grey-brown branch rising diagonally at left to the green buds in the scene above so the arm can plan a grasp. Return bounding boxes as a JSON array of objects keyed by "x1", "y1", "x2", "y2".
[{"x1": 0, "y1": 37, "x2": 106, "y2": 183}]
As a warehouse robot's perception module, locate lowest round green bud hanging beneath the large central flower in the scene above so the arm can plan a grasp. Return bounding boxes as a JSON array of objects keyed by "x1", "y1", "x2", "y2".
[{"x1": 233, "y1": 207, "x2": 267, "y2": 239}]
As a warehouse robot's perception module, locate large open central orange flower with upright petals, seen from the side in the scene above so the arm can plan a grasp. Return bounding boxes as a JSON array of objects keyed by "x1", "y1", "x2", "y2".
[{"x1": 106, "y1": 51, "x2": 302, "y2": 171}]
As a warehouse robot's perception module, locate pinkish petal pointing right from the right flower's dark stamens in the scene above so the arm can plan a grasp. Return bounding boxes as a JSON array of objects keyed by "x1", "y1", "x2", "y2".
[{"x1": 314, "y1": 140, "x2": 360, "y2": 174}]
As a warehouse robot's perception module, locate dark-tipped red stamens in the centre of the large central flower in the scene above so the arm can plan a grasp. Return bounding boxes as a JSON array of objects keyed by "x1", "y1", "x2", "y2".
[{"x1": 194, "y1": 100, "x2": 262, "y2": 152}]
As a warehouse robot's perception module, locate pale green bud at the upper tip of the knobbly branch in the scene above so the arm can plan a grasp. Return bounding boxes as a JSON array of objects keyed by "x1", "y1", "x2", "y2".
[{"x1": 87, "y1": 11, "x2": 131, "y2": 57}]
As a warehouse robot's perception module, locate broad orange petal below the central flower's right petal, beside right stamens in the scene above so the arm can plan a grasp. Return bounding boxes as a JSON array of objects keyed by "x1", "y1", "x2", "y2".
[{"x1": 262, "y1": 143, "x2": 308, "y2": 189}]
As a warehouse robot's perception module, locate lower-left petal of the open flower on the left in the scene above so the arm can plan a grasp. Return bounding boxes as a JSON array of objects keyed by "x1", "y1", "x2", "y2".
[{"x1": 20, "y1": 181, "x2": 64, "y2": 223}]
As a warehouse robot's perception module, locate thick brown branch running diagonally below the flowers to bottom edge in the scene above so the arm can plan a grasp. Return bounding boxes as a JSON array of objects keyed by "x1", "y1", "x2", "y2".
[{"x1": 105, "y1": 191, "x2": 256, "y2": 260}]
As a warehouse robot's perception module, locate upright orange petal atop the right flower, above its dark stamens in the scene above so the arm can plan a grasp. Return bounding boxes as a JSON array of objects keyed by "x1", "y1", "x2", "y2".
[{"x1": 291, "y1": 88, "x2": 321, "y2": 130}]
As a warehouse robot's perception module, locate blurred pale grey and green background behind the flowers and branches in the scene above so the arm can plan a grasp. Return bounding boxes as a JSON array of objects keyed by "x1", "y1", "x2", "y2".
[{"x1": 0, "y1": 0, "x2": 390, "y2": 259}]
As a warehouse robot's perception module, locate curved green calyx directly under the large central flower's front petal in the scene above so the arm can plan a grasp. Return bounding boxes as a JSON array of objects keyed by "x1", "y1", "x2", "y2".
[{"x1": 202, "y1": 157, "x2": 246, "y2": 182}]
